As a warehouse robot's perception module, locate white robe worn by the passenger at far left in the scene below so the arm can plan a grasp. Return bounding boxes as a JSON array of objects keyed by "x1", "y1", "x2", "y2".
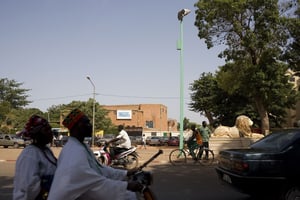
[{"x1": 13, "y1": 145, "x2": 56, "y2": 200}]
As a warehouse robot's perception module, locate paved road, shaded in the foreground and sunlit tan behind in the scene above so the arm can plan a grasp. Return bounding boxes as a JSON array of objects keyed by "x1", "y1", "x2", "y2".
[{"x1": 0, "y1": 147, "x2": 249, "y2": 200}]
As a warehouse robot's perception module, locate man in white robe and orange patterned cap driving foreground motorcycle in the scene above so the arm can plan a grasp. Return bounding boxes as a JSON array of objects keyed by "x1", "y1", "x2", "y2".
[{"x1": 48, "y1": 109, "x2": 143, "y2": 200}]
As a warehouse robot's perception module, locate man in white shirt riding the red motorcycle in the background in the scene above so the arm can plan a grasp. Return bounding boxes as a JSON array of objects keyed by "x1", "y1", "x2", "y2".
[{"x1": 108, "y1": 125, "x2": 131, "y2": 158}]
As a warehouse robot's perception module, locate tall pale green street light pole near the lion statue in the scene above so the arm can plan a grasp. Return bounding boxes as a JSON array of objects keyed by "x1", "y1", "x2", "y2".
[{"x1": 177, "y1": 9, "x2": 191, "y2": 149}]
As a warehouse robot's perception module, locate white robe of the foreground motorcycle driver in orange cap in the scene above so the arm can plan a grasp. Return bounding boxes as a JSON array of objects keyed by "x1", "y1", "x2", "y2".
[{"x1": 48, "y1": 137, "x2": 136, "y2": 200}]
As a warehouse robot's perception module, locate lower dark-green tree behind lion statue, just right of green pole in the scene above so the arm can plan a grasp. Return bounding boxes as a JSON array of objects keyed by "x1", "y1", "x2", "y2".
[{"x1": 189, "y1": 73, "x2": 258, "y2": 126}]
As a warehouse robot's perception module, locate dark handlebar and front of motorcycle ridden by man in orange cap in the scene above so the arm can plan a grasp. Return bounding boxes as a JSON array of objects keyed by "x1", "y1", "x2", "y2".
[{"x1": 129, "y1": 150, "x2": 163, "y2": 200}]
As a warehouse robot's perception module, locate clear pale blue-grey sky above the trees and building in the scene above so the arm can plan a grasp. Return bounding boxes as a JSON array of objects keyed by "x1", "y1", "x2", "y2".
[{"x1": 0, "y1": 0, "x2": 224, "y2": 123}]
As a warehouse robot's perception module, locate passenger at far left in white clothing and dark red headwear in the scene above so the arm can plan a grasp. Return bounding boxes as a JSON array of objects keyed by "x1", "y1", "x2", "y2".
[{"x1": 13, "y1": 115, "x2": 57, "y2": 200}]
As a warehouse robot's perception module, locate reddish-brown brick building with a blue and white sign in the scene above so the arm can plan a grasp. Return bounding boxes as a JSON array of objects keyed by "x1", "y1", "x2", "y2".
[{"x1": 102, "y1": 104, "x2": 177, "y2": 132}]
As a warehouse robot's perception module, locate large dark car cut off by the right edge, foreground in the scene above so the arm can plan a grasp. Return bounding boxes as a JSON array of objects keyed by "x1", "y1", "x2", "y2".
[{"x1": 216, "y1": 129, "x2": 300, "y2": 200}]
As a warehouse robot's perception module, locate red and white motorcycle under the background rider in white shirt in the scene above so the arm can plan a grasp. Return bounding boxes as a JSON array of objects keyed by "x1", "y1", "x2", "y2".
[{"x1": 94, "y1": 142, "x2": 139, "y2": 169}]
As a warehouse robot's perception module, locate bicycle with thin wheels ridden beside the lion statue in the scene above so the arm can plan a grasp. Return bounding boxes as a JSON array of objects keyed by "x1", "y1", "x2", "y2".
[{"x1": 169, "y1": 145, "x2": 215, "y2": 166}]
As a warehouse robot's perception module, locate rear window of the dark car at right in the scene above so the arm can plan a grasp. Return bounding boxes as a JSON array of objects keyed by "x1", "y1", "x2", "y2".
[{"x1": 251, "y1": 129, "x2": 300, "y2": 152}]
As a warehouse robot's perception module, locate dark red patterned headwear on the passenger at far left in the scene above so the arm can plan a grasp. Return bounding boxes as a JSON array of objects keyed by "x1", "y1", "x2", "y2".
[{"x1": 19, "y1": 115, "x2": 50, "y2": 138}]
